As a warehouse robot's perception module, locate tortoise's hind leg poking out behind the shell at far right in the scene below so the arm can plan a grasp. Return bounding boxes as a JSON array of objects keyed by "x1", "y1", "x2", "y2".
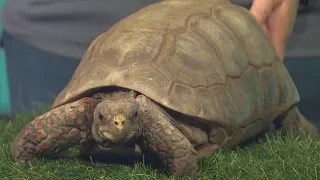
[{"x1": 275, "y1": 107, "x2": 319, "y2": 139}]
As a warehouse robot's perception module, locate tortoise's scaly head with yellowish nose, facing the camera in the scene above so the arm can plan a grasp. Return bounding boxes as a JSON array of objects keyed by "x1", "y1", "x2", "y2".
[{"x1": 92, "y1": 94, "x2": 142, "y2": 147}]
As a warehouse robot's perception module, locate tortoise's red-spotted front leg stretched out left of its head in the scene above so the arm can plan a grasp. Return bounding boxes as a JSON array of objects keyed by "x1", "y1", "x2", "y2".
[{"x1": 11, "y1": 98, "x2": 98, "y2": 163}]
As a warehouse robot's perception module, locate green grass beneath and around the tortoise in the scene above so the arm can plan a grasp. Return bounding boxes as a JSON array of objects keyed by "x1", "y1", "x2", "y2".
[{"x1": 0, "y1": 107, "x2": 320, "y2": 180}]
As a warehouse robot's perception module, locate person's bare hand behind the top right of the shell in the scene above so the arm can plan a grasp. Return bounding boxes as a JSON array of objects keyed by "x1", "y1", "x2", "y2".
[{"x1": 250, "y1": 0, "x2": 299, "y2": 60}]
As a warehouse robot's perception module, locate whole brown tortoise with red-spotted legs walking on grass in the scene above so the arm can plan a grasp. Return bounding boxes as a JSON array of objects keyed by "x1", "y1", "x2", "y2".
[{"x1": 12, "y1": 0, "x2": 319, "y2": 178}]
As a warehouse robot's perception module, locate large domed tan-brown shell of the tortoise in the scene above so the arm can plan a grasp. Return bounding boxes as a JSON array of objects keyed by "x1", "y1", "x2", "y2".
[{"x1": 53, "y1": 0, "x2": 300, "y2": 126}]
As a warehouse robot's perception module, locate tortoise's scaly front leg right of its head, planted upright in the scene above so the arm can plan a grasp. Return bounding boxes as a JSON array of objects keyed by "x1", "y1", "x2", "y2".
[{"x1": 137, "y1": 95, "x2": 197, "y2": 178}]
